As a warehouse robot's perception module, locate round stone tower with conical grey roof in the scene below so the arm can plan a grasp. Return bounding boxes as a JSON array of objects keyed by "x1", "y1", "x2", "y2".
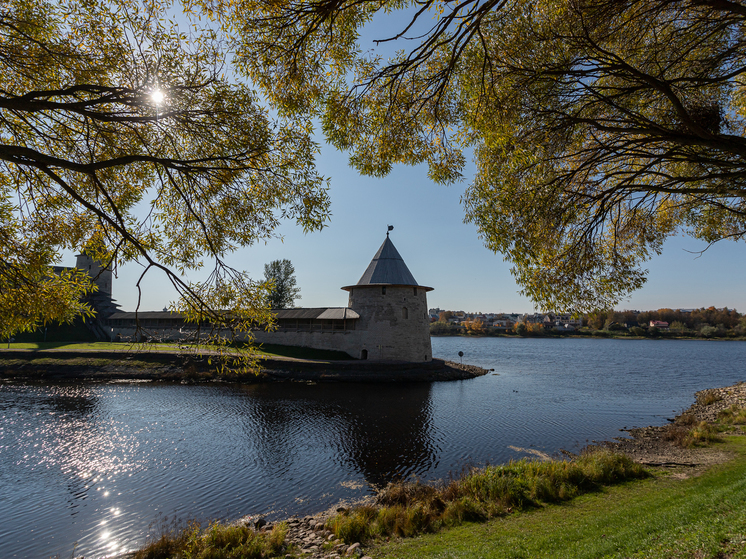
[{"x1": 342, "y1": 233, "x2": 433, "y2": 362}]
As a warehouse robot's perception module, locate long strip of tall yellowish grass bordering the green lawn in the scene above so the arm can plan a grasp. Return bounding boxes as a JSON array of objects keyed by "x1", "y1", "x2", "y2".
[{"x1": 326, "y1": 450, "x2": 647, "y2": 543}]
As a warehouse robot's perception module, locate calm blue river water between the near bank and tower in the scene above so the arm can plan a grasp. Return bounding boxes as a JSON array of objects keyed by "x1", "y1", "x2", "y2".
[{"x1": 0, "y1": 338, "x2": 746, "y2": 558}]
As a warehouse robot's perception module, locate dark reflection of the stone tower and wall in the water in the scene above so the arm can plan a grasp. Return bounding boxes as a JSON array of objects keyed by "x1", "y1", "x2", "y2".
[{"x1": 238, "y1": 383, "x2": 436, "y2": 486}]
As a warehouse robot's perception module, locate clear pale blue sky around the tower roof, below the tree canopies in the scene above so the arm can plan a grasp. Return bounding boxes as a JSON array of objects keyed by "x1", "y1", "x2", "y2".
[{"x1": 77, "y1": 141, "x2": 746, "y2": 313}]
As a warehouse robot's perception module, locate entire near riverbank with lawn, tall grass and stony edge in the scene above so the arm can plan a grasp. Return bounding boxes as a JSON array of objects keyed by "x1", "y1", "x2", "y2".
[{"x1": 129, "y1": 384, "x2": 746, "y2": 559}]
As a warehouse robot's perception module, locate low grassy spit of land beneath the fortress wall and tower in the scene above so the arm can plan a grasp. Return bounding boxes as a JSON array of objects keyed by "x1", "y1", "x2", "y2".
[{"x1": 0, "y1": 349, "x2": 488, "y2": 383}]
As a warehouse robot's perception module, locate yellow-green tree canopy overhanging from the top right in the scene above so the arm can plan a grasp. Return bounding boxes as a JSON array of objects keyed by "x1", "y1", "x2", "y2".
[{"x1": 219, "y1": 0, "x2": 746, "y2": 311}]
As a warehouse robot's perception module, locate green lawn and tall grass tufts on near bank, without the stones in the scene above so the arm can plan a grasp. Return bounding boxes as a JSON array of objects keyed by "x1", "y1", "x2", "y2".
[{"x1": 128, "y1": 442, "x2": 746, "y2": 559}]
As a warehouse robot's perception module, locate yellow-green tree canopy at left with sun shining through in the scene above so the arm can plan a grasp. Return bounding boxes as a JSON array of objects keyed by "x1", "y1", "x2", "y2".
[{"x1": 0, "y1": 0, "x2": 329, "y2": 344}]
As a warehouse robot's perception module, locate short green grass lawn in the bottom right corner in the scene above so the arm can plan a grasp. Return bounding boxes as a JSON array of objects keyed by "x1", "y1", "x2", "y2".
[{"x1": 366, "y1": 436, "x2": 746, "y2": 559}]
